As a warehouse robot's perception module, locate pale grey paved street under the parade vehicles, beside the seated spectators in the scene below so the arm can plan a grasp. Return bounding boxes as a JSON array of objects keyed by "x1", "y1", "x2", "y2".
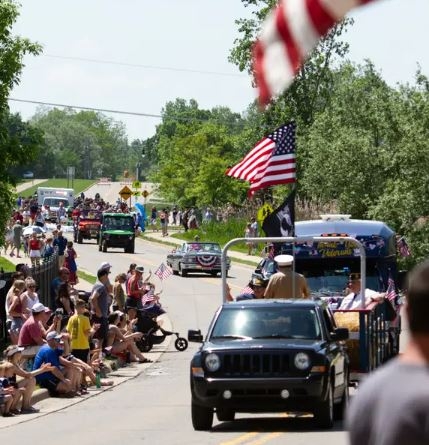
[{"x1": 0, "y1": 234, "x2": 347, "y2": 445}]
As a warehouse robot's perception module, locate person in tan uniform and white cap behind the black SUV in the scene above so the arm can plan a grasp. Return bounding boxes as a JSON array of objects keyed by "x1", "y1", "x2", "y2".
[{"x1": 264, "y1": 255, "x2": 310, "y2": 299}]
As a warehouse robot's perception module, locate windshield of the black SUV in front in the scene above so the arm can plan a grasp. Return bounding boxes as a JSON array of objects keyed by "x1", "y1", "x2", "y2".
[{"x1": 210, "y1": 307, "x2": 320, "y2": 340}]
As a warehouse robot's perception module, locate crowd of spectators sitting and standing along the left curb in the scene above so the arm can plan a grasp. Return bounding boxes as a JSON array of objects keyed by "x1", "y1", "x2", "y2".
[{"x1": 0, "y1": 253, "x2": 159, "y2": 417}]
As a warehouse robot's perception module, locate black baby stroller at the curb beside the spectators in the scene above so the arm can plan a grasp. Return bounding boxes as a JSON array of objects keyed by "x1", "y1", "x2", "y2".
[{"x1": 135, "y1": 308, "x2": 188, "y2": 352}]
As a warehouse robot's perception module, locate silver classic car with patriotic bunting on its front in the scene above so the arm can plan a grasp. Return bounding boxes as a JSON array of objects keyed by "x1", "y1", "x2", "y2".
[{"x1": 167, "y1": 242, "x2": 231, "y2": 277}]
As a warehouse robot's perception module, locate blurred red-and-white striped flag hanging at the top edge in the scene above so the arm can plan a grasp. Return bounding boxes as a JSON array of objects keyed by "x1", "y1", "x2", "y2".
[{"x1": 253, "y1": 0, "x2": 374, "y2": 105}]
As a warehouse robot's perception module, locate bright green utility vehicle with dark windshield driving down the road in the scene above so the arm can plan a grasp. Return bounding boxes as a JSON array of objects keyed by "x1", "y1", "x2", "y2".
[{"x1": 98, "y1": 213, "x2": 136, "y2": 253}]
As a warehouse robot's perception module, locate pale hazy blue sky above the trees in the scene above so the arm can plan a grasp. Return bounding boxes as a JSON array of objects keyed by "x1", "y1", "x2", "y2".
[{"x1": 9, "y1": 0, "x2": 429, "y2": 141}]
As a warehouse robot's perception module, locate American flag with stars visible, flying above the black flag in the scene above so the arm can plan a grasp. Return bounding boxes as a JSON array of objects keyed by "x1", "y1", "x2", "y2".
[{"x1": 226, "y1": 122, "x2": 296, "y2": 195}]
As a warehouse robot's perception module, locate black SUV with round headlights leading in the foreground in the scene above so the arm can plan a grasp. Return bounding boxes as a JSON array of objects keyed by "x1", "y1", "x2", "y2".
[{"x1": 188, "y1": 300, "x2": 349, "y2": 430}]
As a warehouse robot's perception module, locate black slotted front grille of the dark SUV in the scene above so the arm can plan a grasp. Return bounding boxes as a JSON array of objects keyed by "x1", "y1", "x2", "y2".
[{"x1": 220, "y1": 353, "x2": 289, "y2": 377}]
